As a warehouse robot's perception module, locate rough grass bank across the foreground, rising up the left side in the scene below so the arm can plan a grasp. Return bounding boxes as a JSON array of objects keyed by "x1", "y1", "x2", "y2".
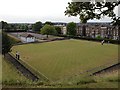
[{"x1": 2, "y1": 55, "x2": 120, "y2": 88}]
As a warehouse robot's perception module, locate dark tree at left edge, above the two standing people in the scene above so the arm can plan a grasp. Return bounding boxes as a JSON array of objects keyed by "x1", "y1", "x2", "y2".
[{"x1": 2, "y1": 32, "x2": 12, "y2": 55}]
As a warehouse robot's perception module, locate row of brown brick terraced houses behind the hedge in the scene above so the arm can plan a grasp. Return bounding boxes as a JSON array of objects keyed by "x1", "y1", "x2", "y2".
[{"x1": 76, "y1": 23, "x2": 119, "y2": 40}]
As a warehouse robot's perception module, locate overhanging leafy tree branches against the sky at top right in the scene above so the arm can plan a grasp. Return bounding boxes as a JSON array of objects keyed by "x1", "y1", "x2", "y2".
[{"x1": 65, "y1": 0, "x2": 120, "y2": 25}]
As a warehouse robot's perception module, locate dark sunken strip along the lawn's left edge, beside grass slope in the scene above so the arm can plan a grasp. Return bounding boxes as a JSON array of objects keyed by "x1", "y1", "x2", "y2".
[{"x1": 5, "y1": 54, "x2": 39, "y2": 81}]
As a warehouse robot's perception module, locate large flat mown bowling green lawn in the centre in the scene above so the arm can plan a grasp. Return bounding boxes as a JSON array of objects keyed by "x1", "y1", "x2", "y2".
[{"x1": 12, "y1": 40, "x2": 118, "y2": 81}]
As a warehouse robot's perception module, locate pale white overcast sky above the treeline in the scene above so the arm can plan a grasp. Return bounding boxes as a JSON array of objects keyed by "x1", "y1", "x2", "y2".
[{"x1": 0, "y1": 0, "x2": 118, "y2": 23}]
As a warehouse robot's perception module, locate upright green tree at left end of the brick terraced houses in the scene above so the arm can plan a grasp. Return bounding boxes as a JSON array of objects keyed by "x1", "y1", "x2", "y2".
[{"x1": 67, "y1": 22, "x2": 76, "y2": 36}]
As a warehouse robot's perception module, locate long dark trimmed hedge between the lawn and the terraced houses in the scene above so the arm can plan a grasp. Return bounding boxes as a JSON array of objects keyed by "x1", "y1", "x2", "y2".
[{"x1": 57, "y1": 35, "x2": 120, "y2": 44}]
